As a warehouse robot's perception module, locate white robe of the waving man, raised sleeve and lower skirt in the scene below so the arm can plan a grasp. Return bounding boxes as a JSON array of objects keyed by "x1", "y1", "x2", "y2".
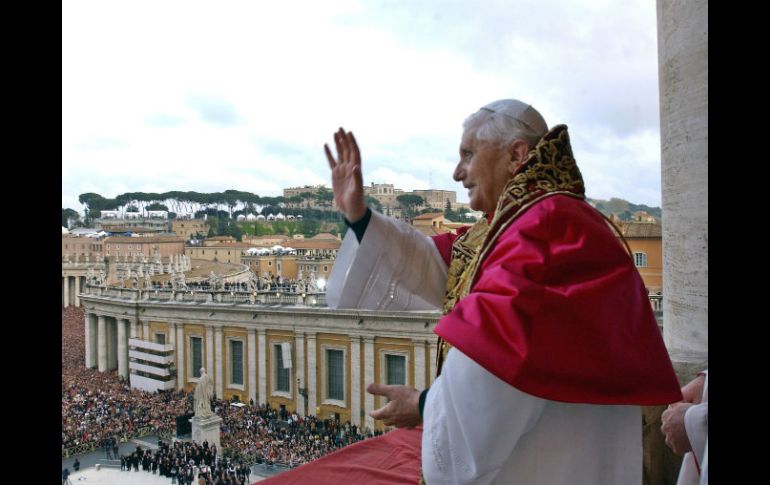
[{"x1": 327, "y1": 211, "x2": 642, "y2": 485}]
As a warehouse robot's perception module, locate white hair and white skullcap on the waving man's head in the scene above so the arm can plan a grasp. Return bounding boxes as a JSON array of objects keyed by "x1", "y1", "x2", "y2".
[{"x1": 463, "y1": 99, "x2": 548, "y2": 148}]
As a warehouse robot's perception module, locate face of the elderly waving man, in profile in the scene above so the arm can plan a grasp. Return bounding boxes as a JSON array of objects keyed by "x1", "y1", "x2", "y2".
[{"x1": 453, "y1": 124, "x2": 514, "y2": 213}]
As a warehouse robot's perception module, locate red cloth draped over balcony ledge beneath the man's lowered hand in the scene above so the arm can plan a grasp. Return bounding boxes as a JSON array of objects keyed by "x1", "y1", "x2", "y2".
[{"x1": 258, "y1": 426, "x2": 422, "y2": 485}]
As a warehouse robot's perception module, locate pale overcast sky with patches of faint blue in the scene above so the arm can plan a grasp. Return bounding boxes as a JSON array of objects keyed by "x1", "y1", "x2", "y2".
[{"x1": 62, "y1": 0, "x2": 660, "y2": 216}]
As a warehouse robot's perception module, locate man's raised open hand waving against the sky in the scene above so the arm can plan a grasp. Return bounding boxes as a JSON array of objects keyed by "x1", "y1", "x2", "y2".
[{"x1": 324, "y1": 128, "x2": 366, "y2": 222}]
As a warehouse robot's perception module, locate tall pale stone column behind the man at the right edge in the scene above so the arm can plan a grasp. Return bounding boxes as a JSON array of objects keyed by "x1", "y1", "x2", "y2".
[{"x1": 658, "y1": 0, "x2": 708, "y2": 378}]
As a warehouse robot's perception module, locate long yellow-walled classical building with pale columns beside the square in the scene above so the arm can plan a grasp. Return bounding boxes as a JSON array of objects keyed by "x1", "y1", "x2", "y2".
[{"x1": 81, "y1": 287, "x2": 440, "y2": 429}]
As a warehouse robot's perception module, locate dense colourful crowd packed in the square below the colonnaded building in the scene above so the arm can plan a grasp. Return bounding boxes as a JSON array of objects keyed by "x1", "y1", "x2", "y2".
[{"x1": 62, "y1": 307, "x2": 379, "y2": 468}]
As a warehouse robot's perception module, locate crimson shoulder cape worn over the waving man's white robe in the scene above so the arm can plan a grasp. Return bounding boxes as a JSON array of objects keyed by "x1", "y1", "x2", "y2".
[{"x1": 434, "y1": 195, "x2": 682, "y2": 405}]
